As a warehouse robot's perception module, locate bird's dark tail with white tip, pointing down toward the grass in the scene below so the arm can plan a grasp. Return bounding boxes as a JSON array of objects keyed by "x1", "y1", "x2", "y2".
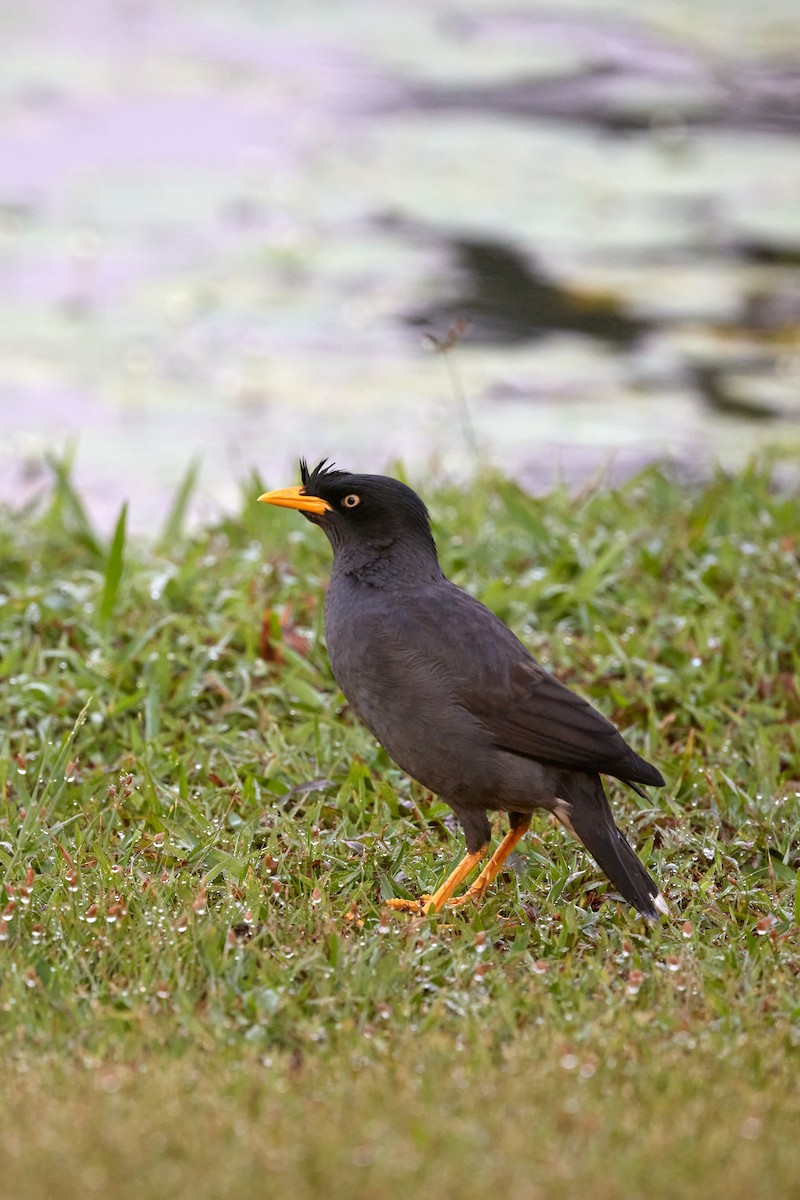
[{"x1": 553, "y1": 774, "x2": 669, "y2": 920}]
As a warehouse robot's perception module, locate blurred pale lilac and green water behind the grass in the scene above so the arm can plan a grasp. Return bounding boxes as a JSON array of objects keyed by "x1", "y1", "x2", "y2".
[{"x1": 0, "y1": 0, "x2": 800, "y2": 532}]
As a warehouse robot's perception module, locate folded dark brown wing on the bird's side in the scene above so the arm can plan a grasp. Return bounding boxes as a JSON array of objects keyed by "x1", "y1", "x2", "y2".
[{"x1": 383, "y1": 583, "x2": 663, "y2": 784}]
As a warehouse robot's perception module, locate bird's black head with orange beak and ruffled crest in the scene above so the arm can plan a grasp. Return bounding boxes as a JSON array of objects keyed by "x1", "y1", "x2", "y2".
[{"x1": 259, "y1": 458, "x2": 437, "y2": 573}]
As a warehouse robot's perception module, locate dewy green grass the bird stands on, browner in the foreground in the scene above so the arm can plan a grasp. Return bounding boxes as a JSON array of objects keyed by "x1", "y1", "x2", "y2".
[{"x1": 0, "y1": 453, "x2": 800, "y2": 1200}]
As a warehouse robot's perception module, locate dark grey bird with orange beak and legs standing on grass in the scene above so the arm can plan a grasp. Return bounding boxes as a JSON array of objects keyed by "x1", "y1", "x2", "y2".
[{"x1": 258, "y1": 458, "x2": 669, "y2": 923}]
